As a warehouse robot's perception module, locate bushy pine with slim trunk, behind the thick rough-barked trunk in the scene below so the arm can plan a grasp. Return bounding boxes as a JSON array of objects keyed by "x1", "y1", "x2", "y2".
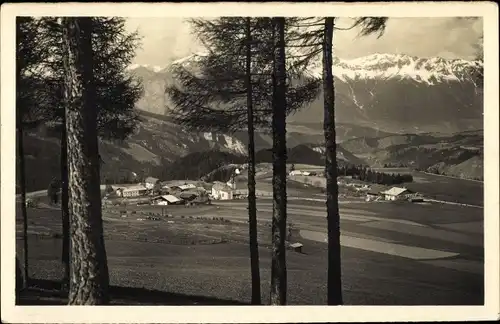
[{"x1": 37, "y1": 17, "x2": 142, "y2": 286}]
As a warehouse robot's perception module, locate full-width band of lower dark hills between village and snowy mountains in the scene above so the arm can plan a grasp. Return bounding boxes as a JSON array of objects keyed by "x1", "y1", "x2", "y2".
[{"x1": 20, "y1": 112, "x2": 483, "y2": 195}]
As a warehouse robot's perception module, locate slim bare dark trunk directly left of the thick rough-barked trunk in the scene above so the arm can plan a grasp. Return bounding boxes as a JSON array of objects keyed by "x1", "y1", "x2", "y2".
[{"x1": 61, "y1": 118, "x2": 70, "y2": 290}]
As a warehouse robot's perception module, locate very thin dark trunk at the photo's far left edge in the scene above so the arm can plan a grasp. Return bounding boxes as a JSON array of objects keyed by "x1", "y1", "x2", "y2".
[{"x1": 17, "y1": 126, "x2": 29, "y2": 287}]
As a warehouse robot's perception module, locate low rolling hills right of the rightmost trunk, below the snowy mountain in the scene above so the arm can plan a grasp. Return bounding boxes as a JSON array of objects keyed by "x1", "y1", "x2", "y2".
[{"x1": 342, "y1": 131, "x2": 484, "y2": 179}]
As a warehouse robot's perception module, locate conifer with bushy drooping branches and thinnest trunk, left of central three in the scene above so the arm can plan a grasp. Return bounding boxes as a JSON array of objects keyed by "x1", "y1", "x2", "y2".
[{"x1": 166, "y1": 17, "x2": 319, "y2": 304}]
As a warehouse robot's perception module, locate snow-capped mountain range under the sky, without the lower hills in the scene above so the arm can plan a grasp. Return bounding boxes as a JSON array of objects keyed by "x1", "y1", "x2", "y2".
[{"x1": 130, "y1": 53, "x2": 483, "y2": 132}]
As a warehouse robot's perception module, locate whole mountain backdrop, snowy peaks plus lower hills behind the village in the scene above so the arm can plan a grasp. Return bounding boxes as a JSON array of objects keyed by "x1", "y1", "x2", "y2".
[{"x1": 17, "y1": 54, "x2": 483, "y2": 190}]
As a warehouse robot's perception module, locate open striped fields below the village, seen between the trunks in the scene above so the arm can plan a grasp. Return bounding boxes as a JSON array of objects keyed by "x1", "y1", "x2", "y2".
[{"x1": 17, "y1": 194, "x2": 484, "y2": 305}]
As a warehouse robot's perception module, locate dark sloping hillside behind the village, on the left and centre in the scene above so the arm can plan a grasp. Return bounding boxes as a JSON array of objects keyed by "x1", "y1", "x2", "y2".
[{"x1": 16, "y1": 112, "x2": 359, "y2": 191}]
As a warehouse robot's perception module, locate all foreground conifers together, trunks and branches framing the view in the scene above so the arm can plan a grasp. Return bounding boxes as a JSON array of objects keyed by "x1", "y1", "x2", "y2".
[{"x1": 16, "y1": 17, "x2": 392, "y2": 305}]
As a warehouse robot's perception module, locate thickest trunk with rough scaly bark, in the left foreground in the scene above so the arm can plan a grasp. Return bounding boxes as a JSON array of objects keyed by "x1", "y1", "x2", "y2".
[{"x1": 63, "y1": 17, "x2": 109, "y2": 305}]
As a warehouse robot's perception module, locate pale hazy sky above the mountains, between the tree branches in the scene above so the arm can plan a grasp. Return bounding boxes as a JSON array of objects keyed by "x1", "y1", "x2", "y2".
[{"x1": 127, "y1": 17, "x2": 483, "y2": 66}]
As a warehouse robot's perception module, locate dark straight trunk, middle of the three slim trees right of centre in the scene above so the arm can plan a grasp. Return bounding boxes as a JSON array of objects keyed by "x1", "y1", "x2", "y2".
[{"x1": 271, "y1": 17, "x2": 287, "y2": 305}]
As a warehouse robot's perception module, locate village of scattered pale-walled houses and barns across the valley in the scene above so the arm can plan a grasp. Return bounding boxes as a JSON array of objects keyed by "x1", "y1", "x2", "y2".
[{"x1": 103, "y1": 168, "x2": 424, "y2": 206}]
